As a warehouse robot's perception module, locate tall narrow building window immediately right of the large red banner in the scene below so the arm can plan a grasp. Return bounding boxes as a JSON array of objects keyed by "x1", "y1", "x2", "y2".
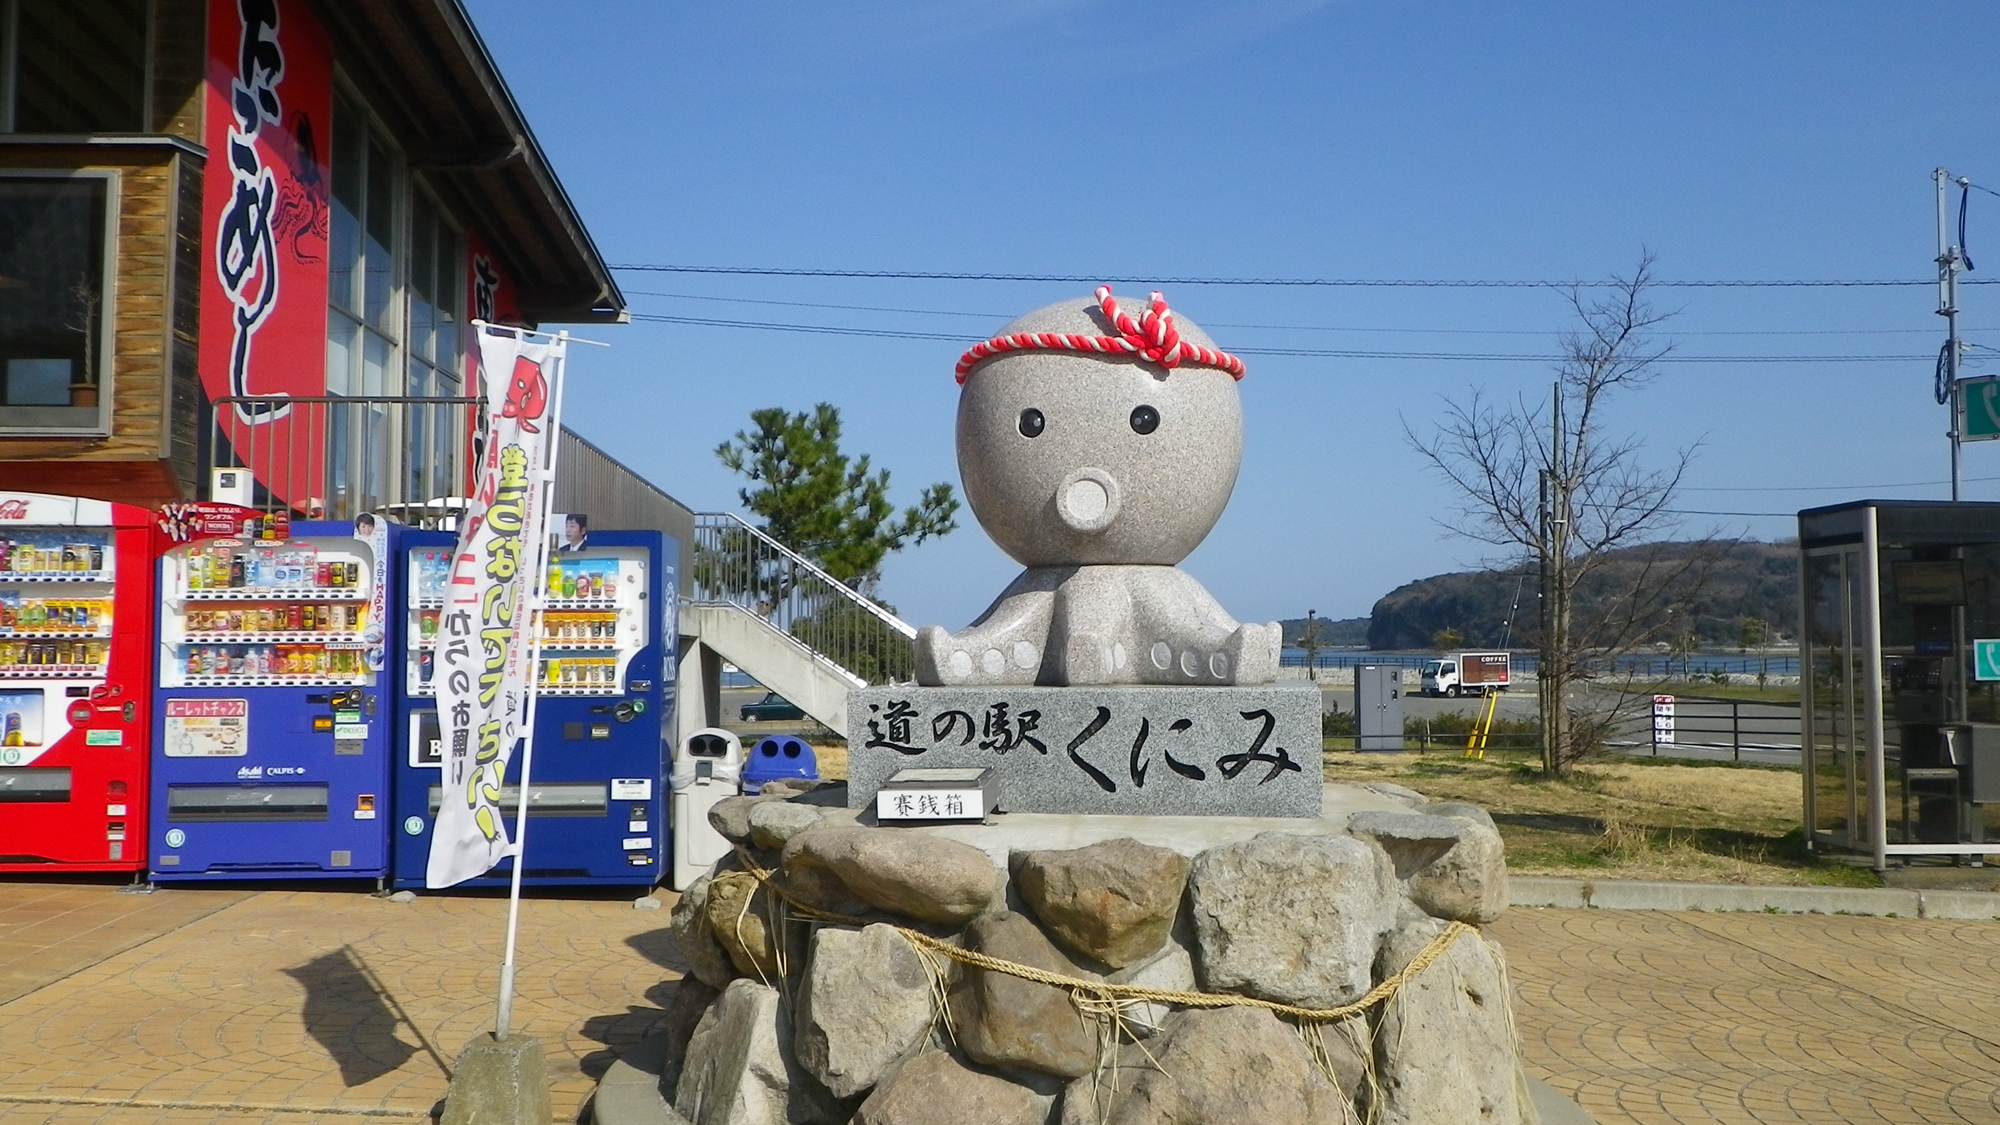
[{"x1": 326, "y1": 96, "x2": 404, "y2": 516}]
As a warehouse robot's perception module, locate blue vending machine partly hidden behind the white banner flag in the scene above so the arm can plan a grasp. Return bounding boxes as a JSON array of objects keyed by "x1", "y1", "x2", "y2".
[{"x1": 394, "y1": 530, "x2": 680, "y2": 889}]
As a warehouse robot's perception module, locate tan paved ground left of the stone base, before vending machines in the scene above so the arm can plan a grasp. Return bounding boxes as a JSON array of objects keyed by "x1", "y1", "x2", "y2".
[{"x1": 0, "y1": 885, "x2": 680, "y2": 1125}]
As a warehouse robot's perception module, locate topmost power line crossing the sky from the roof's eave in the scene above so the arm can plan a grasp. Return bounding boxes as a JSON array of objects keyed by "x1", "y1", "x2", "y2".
[{"x1": 612, "y1": 262, "x2": 2000, "y2": 288}]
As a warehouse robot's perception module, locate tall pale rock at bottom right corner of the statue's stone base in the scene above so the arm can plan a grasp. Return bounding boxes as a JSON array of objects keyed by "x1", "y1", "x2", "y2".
[{"x1": 1376, "y1": 919, "x2": 1536, "y2": 1125}]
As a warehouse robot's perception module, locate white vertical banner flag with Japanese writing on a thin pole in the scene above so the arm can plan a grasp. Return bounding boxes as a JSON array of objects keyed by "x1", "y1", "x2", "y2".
[{"x1": 424, "y1": 324, "x2": 568, "y2": 887}]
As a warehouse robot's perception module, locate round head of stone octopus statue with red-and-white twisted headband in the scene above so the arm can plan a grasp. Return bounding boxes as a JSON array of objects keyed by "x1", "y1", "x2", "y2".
[{"x1": 958, "y1": 288, "x2": 1244, "y2": 567}]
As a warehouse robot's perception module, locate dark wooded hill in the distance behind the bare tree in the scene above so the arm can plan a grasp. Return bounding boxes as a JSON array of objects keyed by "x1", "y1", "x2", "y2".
[{"x1": 1368, "y1": 542, "x2": 1798, "y2": 649}]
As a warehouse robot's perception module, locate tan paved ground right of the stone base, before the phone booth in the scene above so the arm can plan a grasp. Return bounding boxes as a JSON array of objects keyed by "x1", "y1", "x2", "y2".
[{"x1": 1494, "y1": 909, "x2": 2000, "y2": 1125}]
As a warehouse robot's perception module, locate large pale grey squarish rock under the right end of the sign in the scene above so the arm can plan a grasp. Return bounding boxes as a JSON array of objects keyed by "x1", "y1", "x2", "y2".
[{"x1": 1188, "y1": 833, "x2": 1402, "y2": 1007}]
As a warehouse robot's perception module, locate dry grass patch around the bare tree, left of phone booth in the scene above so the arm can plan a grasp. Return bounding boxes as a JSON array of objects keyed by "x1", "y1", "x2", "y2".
[{"x1": 1326, "y1": 751, "x2": 1880, "y2": 887}]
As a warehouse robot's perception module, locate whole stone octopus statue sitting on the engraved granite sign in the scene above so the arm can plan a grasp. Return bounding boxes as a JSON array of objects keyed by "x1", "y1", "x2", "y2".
[{"x1": 916, "y1": 286, "x2": 1282, "y2": 687}]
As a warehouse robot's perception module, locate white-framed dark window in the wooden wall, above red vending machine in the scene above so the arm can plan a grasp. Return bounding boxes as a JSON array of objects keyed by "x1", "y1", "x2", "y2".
[{"x1": 0, "y1": 172, "x2": 118, "y2": 432}]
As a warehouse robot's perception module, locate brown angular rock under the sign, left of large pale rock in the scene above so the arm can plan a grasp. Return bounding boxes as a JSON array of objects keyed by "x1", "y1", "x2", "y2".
[{"x1": 1008, "y1": 839, "x2": 1188, "y2": 969}]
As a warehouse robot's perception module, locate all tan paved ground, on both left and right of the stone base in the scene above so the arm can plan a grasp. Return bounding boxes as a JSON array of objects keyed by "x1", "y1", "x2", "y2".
[{"x1": 11, "y1": 883, "x2": 2000, "y2": 1125}]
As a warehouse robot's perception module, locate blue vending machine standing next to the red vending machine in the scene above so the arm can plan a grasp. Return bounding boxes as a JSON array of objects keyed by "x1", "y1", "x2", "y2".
[{"x1": 150, "y1": 516, "x2": 400, "y2": 883}]
